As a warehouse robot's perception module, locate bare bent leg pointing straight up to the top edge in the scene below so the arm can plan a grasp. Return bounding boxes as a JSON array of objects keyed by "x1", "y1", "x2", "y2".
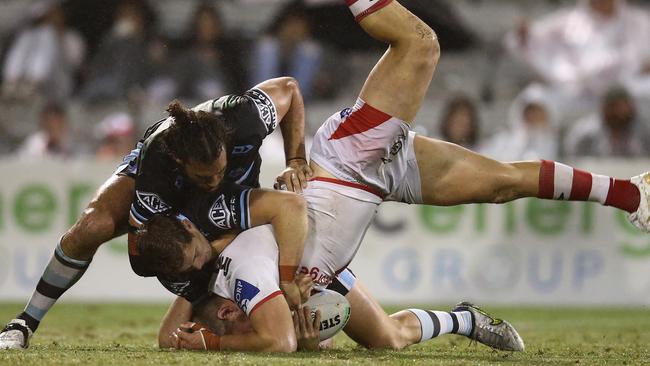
[{"x1": 346, "y1": 0, "x2": 440, "y2": 122}]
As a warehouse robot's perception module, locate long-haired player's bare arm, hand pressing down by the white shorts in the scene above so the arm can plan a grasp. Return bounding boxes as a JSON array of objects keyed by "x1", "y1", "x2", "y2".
[{"x1": 255, "y1": 77, "x2": 312, "y2": 192}]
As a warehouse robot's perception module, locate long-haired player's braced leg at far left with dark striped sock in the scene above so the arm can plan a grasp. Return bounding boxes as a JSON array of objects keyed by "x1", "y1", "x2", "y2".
[{"x1": 0, "y1": 175, "x2": 135, "y2": 349}]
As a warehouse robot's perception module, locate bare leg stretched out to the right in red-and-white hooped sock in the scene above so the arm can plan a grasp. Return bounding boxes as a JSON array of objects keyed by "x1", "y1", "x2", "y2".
[{"x1": 414, "y1": 136, "x2": 649, "y2": 230}]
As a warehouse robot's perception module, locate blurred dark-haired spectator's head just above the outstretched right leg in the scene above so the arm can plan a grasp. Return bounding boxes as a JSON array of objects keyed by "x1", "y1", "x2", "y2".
[{"x1": 440, "y1": 95, "x2": 480, "y2": 150}]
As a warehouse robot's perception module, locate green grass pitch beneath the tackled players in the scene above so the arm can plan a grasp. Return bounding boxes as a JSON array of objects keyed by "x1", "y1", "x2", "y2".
[{"x1": 0, "y1": 304, "x2": 650, "y2": 366}]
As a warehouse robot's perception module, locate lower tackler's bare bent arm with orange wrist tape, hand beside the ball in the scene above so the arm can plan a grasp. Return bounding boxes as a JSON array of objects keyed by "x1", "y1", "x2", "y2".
[{"x1": 249, "y1": 189, "x2": 309, "y2": 308}]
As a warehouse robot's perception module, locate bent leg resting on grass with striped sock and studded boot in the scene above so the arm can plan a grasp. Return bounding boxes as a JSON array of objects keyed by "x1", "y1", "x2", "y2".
[{"x1": 343, "y1": 280, "x2": 524, "y2": 351}]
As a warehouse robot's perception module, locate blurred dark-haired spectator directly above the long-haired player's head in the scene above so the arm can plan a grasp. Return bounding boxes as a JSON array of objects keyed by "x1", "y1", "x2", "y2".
[{"x1": 175, "y1": 2, "x2": 228, "y2": 100}]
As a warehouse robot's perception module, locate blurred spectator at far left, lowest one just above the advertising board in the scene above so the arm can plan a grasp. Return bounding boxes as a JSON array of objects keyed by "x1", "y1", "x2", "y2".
[{"x1": 17, "y1": 104, "x2": 72, "y2": 158}]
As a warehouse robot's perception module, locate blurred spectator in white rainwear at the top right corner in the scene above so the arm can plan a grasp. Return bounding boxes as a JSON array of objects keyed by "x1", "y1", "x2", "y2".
[{"x1": 505, "y1": 0, "x2": 650, "y2": 117}]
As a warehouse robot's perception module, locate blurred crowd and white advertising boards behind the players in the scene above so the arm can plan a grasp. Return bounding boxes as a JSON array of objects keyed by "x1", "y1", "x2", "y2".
[{"x1": 0, "y1": 0, "x2": 650, "y2": 312}]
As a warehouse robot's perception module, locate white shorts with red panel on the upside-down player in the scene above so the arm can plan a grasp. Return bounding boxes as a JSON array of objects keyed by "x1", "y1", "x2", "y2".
[{"x1": 310, "y1": 99, "x2": 422, "y2": 204}]
